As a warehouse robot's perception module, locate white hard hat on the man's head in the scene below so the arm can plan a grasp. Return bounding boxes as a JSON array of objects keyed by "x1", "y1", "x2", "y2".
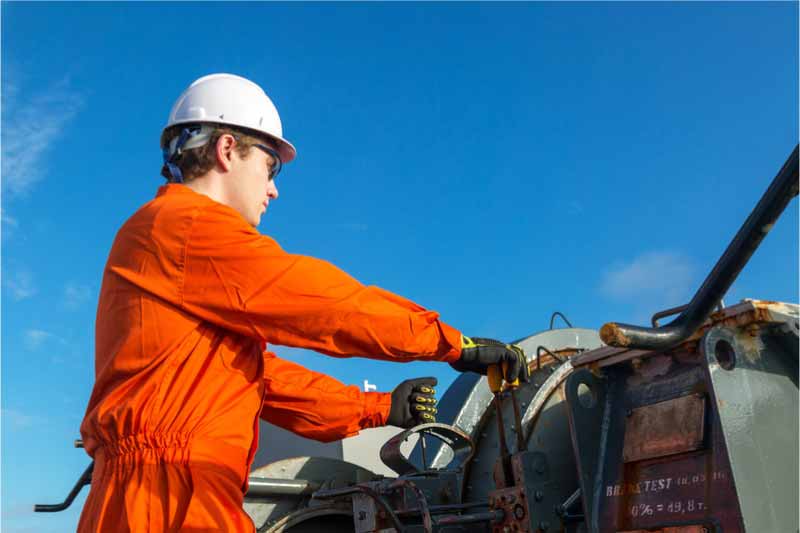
[{"x1": 164, "y1": 74, "x2": 297, "y2": 163}]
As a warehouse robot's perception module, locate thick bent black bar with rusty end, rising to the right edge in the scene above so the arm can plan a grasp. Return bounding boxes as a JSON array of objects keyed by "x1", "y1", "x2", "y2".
[{"x1": 600, "y1": 146, "x2": 798, "y2": 350}]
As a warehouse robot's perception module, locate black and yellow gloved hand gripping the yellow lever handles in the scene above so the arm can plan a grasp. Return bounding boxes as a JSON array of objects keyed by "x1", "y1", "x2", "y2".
[{"x1": 450, "y1": 335, "x2": 530, "y2": 382}]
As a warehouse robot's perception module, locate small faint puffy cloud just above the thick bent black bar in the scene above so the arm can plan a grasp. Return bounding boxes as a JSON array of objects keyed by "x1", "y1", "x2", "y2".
[{"x1": 600, "y1": 251, "x2": 695, "y2": 306}]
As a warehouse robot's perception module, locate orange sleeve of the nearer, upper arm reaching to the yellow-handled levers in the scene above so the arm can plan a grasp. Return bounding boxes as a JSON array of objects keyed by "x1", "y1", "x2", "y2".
[{"x1": 181, "y1": 204, "x2": 461, "y2": 362}]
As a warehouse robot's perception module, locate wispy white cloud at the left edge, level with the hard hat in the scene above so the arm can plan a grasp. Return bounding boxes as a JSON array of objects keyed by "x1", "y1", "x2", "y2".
[{"x1": 0, "y1": 80, "x2": 83, "y2": 196}]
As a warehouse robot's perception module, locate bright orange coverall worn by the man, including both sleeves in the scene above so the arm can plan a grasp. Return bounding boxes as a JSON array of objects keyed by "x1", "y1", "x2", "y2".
[{"x1": 78, "y1": 184, "x2": 461, "y2": 532}]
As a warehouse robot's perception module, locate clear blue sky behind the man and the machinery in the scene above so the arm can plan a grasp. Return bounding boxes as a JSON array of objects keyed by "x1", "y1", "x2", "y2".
[{"x1": 1, "y1": 2, "x2": 798, "y2": 532}]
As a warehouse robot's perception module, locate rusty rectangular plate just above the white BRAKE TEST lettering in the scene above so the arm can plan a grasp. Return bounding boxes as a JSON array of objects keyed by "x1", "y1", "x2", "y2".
[{"x1": 622, "y1": 394, "x2": 705, "y2": 463}]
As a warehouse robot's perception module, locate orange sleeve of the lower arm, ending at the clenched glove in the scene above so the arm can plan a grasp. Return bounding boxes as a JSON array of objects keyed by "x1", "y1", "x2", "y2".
[{"x1": 261, "y1": 352, "x2": 392, "y2": 442}]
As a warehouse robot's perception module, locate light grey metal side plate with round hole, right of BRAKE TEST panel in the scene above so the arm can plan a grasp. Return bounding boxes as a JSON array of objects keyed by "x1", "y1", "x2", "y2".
[{"x1": 701, "y1": 322, "x2": 800, "y2": 532}]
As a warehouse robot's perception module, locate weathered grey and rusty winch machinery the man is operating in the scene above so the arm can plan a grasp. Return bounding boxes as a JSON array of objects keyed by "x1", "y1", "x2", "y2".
[{"x1": 37, "y1": 148, "x2": 800, "y2": 533}]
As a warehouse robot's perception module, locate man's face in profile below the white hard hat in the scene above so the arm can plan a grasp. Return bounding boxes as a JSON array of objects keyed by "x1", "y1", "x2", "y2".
[{"x1": 227, "y1": 140, "x2": 278, "y2": 227}]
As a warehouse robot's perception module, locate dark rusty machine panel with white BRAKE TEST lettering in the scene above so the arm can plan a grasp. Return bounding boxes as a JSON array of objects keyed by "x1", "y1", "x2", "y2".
[{"x1": 567, "y1": 344, "x2": 744, "y2": 533}]
